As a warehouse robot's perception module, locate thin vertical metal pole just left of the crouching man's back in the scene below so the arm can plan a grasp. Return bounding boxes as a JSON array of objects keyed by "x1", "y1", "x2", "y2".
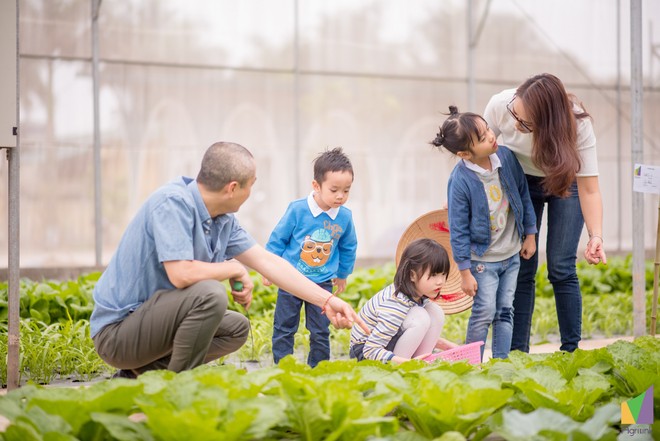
[{"x1": 92, "y1": 0, "x2": 103, "y2": 267}]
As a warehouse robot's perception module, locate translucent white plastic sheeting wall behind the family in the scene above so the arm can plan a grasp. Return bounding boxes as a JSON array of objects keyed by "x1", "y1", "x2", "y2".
[{"x1": 0, "y1": 0, "x2": 660, "y2": 267}]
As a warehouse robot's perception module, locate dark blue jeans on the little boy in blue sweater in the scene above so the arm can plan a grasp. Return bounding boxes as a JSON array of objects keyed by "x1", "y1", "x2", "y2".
[{"x1": 273, "y1": 281, "x2": 332, "y2": 367}]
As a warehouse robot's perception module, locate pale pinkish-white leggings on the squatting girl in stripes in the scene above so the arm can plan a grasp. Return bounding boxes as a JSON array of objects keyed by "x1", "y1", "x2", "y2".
[{"x1": 392, "y1": 302, "x2": 445, "y2": 358}]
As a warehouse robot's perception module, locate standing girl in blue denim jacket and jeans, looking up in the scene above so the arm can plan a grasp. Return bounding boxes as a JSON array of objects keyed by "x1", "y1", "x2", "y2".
[{"x1": 432, "y1": 106, "x2": 537, "y2": 358}]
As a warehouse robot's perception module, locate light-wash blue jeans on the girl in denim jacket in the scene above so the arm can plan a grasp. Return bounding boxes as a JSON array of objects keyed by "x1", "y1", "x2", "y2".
[{"x1": 465, "y1": 254, "x2": 520, "y2": 359}]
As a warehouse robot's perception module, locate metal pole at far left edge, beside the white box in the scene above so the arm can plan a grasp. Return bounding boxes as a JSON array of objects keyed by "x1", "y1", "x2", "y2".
[{"x1": 7, "y1": 0, "x2": 21, "y2": 390}]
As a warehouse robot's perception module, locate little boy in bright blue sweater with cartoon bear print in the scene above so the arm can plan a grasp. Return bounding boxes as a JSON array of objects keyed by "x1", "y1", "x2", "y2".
[{"x1": 264, "y1": 148, "x2": 357, "y2": 367}]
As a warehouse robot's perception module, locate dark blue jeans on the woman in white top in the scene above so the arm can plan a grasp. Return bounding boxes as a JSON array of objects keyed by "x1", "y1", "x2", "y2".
[{"x1": 511, "y1": 175, "x2": 584, "y2": 352}]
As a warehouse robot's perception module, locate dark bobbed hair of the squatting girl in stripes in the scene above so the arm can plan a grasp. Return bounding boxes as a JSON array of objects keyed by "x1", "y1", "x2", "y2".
[{"x1": 394, "y1": 238, "x2": 449, "y2": 300}]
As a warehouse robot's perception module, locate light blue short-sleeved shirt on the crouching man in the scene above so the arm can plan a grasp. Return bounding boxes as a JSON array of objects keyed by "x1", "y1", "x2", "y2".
[{"x1": 90, "y1": 176, "x2": 256, "y2": 337}]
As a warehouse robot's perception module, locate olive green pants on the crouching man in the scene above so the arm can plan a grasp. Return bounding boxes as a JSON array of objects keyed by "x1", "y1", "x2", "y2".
[{"x1": 94, "y1": 280, "x2": 250, "y2": 373}]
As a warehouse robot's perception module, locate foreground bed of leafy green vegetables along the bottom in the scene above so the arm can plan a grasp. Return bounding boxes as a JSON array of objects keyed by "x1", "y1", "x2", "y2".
[{"x1": 0, "y1": 337, "x2": 660, "y2": 441}]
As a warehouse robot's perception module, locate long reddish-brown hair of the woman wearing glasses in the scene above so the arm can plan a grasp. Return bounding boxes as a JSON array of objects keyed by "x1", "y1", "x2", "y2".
[{"x1": 516, "y1": 73, "x2": 589, "y2": 197}]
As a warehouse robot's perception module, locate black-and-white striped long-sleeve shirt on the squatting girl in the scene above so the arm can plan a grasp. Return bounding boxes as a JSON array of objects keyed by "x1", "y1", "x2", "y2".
[{"x1": 351, "y1": 284, "x2": 429, "y2": 361}]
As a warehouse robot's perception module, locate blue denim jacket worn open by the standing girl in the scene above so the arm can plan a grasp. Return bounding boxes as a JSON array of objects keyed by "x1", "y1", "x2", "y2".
[{"x1": 447, "y1": 145, "x2": 538, "y2": 270}]
